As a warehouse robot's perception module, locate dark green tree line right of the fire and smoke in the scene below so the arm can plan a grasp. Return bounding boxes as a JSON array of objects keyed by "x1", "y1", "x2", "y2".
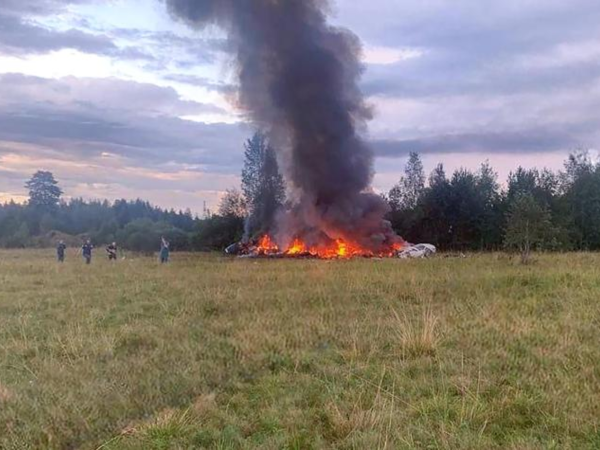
[{"x1": 386, "y1": 151, "x2": 600, "y2": 259}]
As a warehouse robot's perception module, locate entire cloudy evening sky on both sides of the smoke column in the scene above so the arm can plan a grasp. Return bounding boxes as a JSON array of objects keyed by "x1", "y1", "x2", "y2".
[{"x1": 0, "y1": 0, "x2": 600, "y2": 211}]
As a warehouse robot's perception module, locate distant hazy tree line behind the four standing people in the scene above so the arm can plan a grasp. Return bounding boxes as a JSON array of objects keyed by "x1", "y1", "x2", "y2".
[{"x1": 0, "y1": 171, "x2": 198, "y2": 252}]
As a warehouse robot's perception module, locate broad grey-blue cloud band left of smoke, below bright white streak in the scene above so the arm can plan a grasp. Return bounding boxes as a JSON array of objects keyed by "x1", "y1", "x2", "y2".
[{"x1": 0, "y1": 75, "x2": 249, "y2": 173}]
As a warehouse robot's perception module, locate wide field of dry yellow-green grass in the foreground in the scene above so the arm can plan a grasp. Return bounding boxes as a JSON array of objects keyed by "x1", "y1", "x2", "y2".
[{"x1": 0, "y1": 251, "x2": 600, "y2": 450}]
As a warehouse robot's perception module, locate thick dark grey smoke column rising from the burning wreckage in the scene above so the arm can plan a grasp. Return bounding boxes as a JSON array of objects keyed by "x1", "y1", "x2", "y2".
[{"x1": 165, "y1": 0, "x2": 400, "y2": 250}]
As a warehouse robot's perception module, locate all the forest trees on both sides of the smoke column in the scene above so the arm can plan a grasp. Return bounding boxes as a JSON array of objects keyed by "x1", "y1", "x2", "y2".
[{"x1": 0, "y1": 133, "x2": 600, "y2": 254}]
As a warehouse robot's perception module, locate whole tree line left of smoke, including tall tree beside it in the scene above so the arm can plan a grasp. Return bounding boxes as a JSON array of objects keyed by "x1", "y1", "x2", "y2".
[{"x1": 0, "y1": 133, "x2": 285, "y2": 252}]
